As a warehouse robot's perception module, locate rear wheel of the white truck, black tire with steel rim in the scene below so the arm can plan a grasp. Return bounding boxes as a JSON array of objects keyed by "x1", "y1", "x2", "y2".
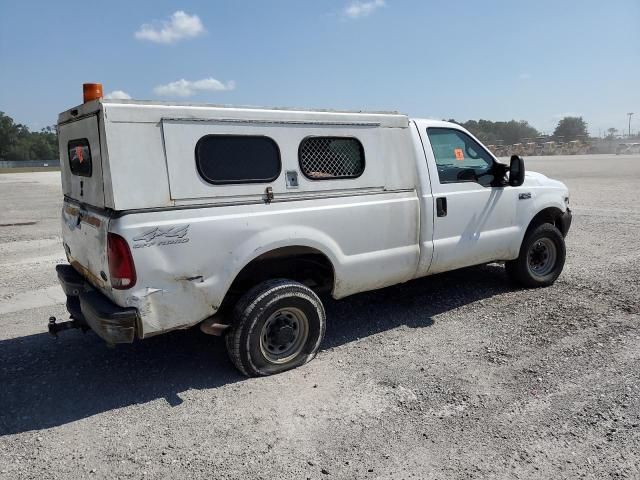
[{"x1": 225, "y1": 279, "x2": 326, "y2": 377}]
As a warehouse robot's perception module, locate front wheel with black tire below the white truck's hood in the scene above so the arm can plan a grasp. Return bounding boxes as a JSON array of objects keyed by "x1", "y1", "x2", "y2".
[{"x1": 505, "y1": 223, "x2": 567, "y2": 288}]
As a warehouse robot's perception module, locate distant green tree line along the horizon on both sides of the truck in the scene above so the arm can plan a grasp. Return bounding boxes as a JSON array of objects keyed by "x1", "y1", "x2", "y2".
[{"x1": 0, "y1": 112, "x2": 588, "y2": 160}]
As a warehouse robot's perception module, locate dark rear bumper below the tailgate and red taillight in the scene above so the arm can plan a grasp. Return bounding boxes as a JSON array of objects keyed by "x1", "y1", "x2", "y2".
[{"x1": 56, "y1": 265, "x2": 138, "y2": 343}]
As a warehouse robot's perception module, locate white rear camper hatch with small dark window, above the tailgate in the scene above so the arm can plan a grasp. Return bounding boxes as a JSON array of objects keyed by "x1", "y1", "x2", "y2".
[{"x1": 58, "y1": 112, "x2": 105, "y2": 207}]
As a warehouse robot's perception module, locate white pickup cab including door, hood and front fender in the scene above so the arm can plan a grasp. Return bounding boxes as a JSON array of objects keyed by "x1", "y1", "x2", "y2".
[{"x1": 412, "y1": 120, "x2": 568, "y2": 274}]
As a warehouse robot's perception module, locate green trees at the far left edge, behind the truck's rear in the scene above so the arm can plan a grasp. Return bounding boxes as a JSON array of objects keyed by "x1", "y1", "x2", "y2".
[{"x1": 0, "y1": 112, "x2": 58, "y2": 160}]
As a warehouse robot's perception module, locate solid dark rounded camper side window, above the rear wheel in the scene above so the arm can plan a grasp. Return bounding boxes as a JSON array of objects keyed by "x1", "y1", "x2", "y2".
[{"x1": 196, "y1": 135, "x2": 281, "y2": 185}]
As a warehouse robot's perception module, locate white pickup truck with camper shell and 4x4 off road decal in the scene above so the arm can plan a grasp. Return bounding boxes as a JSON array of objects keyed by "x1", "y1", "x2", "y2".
[{"x1": 49, "y1": 95, "x2": 571, "y2": 376}]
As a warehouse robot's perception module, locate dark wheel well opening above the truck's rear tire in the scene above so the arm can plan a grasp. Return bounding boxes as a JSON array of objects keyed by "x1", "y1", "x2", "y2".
[{"x1": 221, "y1": 246, "x2": 335, "y2": 310}]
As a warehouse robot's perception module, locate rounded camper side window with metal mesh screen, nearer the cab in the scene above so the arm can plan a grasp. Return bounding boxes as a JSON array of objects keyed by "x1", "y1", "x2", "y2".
[{"x1": 298, "y1": 137, "x2": 364, "y2": 180}]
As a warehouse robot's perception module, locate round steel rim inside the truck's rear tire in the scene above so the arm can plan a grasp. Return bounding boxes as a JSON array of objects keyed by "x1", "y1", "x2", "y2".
[{"x1": 260, "y1": 307, "x2": 309, "y2": 364}]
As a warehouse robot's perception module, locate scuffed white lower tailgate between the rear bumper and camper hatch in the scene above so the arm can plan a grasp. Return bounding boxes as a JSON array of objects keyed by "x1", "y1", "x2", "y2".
[{"x1": 62, "y1": 199, "x2": 110, "y2": 293}]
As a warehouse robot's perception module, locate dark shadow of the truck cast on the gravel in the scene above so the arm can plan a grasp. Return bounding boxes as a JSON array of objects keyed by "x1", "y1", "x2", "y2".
[{"x1": 0, "y1": 265, "x2": 512, "y2": 435}]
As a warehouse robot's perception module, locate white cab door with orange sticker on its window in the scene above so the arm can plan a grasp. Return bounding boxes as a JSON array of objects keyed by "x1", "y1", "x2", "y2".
[{"x1": 420, "y1": 127, "x2": 519, "y2": 273}]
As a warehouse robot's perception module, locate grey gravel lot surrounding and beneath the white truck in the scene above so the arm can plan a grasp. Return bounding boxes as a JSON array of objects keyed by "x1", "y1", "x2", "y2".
[{"x1": 0, "y1": 155, "x2": 640, "y2": 480}]
